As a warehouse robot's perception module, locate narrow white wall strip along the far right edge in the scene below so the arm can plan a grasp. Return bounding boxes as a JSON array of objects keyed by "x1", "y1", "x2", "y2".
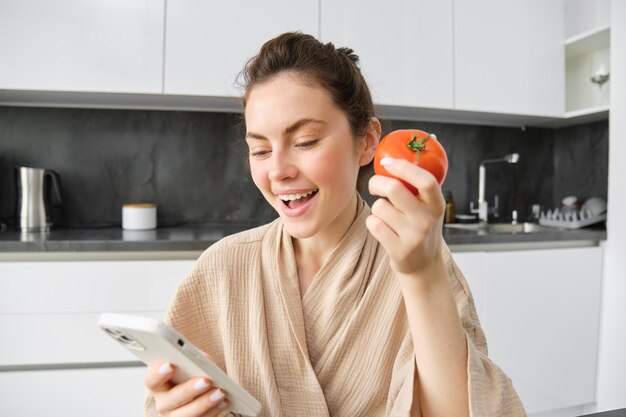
[{"x1": 585, "y1": 0, "x2": 626, "y2": 413}]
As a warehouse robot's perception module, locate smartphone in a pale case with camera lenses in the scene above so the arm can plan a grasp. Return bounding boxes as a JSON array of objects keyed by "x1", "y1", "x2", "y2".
[{"x1": 98, "y1": 313, "x2": 261, "y2": 416}]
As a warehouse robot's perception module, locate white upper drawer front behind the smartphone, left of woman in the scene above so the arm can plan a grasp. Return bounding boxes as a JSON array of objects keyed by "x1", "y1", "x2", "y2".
[{"x1": 0, "y1": 260, "x2": 194, "y2": 364}]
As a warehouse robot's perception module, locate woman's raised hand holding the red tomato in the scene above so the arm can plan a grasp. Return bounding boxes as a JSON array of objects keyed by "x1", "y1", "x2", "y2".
[{"x1": 366, "y1": 158, "x2": 446, "y2": 282}]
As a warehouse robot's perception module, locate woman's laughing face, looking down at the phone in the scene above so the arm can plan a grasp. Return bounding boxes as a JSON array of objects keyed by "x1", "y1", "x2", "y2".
[{"x1": 245, "y1": 73, "x2": 371, "y2": 238}]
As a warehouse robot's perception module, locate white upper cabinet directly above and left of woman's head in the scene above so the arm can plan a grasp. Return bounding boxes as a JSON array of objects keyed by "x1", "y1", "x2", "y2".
[{"x1": 164, "y1": 0, "x2": 319, "y2": 96}]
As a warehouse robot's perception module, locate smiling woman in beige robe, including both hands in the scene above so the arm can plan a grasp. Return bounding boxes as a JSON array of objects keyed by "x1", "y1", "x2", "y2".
[{"x1": 146, "y1": 33, "x2": 525, "y2": 417}]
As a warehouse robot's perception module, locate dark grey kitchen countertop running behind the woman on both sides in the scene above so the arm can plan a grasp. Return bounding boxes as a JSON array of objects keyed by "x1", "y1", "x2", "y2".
[{"x1": 0, "y1": 224, "x2": 607, "y2": 254}]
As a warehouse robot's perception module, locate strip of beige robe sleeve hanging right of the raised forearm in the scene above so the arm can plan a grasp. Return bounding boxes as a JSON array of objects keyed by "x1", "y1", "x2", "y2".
[{"x1": 443, "y1": 245, "x2": 526, "y2": 417}]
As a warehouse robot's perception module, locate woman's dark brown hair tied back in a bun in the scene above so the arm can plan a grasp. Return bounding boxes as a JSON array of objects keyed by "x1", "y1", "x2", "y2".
[{"x1": 238, "y1": 32, "x2": 374, "y2": 191}]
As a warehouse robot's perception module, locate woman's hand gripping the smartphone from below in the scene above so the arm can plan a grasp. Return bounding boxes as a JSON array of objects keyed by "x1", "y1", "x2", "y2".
[{"x1": 145, "y1": 362, "x2": 228, "y2": 417}]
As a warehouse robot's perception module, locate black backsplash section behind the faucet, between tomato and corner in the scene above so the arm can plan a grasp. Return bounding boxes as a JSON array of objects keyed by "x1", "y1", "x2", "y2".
[{"x1": 386, "y1": 122, "x2": 554, "y2": 220}]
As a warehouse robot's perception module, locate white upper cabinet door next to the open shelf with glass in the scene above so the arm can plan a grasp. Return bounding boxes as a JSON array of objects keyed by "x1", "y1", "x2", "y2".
[{"x1": 454, "y1": 0, "x2": 565, "y2": 117}]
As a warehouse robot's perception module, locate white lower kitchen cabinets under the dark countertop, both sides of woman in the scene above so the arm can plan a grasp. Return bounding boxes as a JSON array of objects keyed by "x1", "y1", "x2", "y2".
[{"x1": 0, "y1": 247, "x2": 602, "y2": 417}]
